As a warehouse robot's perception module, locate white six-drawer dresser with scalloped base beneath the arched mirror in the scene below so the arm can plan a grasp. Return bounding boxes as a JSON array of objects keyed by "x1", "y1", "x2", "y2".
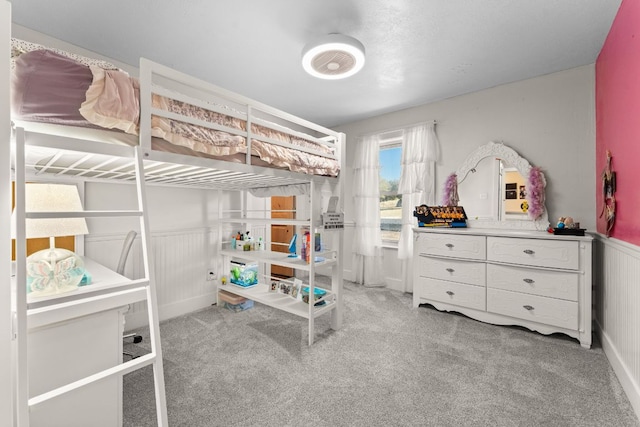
[{"x1": 413, "y1": 228, "x2": 593, "y2": 348}]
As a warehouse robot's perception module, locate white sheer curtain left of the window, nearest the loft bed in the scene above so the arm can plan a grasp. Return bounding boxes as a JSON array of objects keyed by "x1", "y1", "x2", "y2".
[{"x1": 353, "y1": 135, "x2": 385, "y2": 287}]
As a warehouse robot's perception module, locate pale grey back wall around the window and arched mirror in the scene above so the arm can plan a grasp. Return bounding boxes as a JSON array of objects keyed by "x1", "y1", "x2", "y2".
[{"x1": 337, "y1": 65, "x2": 597, "y2": 290}]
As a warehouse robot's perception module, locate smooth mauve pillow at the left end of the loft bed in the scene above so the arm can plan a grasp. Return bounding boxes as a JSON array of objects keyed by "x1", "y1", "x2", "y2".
[{"x1": 11, "y1": 50, "x2": 94, "y2": 127}]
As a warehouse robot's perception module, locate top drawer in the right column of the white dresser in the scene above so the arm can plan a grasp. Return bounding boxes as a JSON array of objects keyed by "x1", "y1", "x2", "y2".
[{"x1": 487, "y1": 237, "x2": 580, "y2": 270}]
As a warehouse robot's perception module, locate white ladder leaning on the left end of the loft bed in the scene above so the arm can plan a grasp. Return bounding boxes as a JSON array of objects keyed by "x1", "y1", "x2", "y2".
[{"x1": 12, "y1": 128, "x2": 168, "y2": 427}]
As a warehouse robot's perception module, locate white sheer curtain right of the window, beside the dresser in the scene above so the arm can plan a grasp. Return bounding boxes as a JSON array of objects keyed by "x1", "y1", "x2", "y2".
[{"x1": 398, "y1": 123, "x2": 440, "y2": 292}]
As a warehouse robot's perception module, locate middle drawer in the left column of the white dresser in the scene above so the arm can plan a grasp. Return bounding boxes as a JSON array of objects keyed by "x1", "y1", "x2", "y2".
[{"x1": 417, "y1": 256, "x2": 486, "y2": 286}]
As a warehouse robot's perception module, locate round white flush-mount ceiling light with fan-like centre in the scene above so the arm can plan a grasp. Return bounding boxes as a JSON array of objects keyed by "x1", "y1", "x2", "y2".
[{"x1": 302, "y1": 34, "x2": 364, "y2": 80}]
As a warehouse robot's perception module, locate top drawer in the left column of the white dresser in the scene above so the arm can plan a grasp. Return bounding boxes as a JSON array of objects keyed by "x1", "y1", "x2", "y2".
[{"x1": 416, "y1": 233, "x2": 487, "y2": 260}]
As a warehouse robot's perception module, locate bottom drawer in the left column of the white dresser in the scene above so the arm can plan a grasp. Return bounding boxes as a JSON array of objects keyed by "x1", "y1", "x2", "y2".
[{"x1": 414, "y1": 277, "x2": 486, "y2": 311}]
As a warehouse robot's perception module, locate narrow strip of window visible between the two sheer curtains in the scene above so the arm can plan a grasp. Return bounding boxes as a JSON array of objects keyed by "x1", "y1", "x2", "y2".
[{"x1": 379, "y1": 131, "x2": 402, "y2": 242}]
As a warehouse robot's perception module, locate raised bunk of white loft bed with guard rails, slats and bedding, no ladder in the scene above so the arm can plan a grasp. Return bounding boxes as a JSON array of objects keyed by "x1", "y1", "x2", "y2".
[{"x1": 11, "y1": 39, "x2": 341, "y2": 189}]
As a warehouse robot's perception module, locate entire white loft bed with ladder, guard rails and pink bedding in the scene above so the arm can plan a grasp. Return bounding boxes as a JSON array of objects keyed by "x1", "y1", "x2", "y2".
[{"x1": 6, "y1": 30, "x2": 345, "y2": 425}]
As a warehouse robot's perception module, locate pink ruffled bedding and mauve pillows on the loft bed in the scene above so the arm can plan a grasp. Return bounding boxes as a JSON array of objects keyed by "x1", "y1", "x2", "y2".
[{"x1": 12, "y1": 50, "x2": 339, "y2": 176}]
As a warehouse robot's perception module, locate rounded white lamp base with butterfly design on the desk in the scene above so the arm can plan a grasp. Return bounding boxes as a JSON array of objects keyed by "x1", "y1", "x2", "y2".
[{"x1": 27, "y1": 248, "x2": 84, "y2": 296}]
